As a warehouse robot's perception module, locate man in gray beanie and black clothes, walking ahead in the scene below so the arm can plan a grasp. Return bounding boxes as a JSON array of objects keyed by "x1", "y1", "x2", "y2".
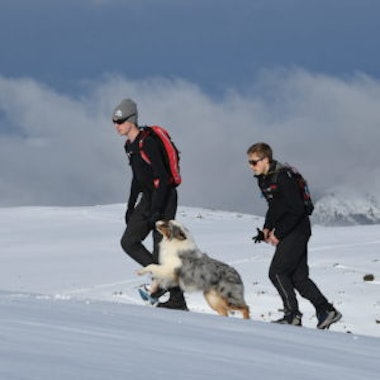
[{"x1": 112, "y1": 99, "x2": 188, "y2": 310}]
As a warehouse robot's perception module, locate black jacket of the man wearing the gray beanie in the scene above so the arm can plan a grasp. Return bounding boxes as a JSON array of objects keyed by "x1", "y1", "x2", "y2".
[{"x1": 125, "y1": 132, "x2": 172, "y2": 216}]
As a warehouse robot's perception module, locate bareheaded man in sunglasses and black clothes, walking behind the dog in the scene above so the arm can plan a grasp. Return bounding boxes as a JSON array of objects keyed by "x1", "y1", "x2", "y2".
[{"x1": 247, "y1": 142, "x2": 342, "y2": 329}]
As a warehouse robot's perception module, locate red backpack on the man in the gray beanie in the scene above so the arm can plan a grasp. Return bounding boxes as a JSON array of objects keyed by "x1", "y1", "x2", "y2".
[{"x1": 139, "y1": 125, "x2": 182, "y2": 186}]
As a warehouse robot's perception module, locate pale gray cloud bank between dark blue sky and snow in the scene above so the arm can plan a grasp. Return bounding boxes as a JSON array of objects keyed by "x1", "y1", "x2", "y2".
[{"x1": 0, "y1": 69, "x2": 380, "y2": 213}]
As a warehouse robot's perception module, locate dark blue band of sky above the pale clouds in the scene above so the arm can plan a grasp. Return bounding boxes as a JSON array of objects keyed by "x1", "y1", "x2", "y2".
[{"x1": 0, "y1": 0, "x2": 380, "y2": 95}]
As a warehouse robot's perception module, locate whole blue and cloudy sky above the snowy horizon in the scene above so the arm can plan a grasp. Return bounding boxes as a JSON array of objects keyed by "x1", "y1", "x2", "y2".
[{"x1": 0, "y1": 0, "x2": 380, "y2": 212}]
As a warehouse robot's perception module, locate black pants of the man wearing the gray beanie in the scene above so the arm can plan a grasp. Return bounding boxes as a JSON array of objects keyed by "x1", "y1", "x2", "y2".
[{"x1": 121, "y1": 188, "x2": 177, "y2": 267}]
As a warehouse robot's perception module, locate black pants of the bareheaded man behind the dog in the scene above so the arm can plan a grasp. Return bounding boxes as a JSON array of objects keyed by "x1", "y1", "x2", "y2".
[{"x1": 269, "y1": 231, "x2": 330, "y2": 314}]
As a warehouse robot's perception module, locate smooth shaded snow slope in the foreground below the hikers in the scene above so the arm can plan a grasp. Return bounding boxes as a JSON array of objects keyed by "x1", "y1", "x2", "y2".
[{"x1": 0, "y1": 293, "x2": 380, "y2": 380}]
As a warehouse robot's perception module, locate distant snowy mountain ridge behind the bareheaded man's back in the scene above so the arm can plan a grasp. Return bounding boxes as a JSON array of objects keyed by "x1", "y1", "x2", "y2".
[{"x1": 311, "y1": 189, "x2": 380, "y2": 226}]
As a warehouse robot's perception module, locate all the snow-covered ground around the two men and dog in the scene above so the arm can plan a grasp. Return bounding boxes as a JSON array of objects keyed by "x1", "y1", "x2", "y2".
[{"x1": 0, "y1": 204, "x2": 380, "y2": 380}]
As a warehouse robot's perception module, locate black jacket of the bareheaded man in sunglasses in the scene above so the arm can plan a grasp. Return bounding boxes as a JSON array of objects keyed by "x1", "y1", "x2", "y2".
[{"x1": 255, "y1": 161, "x2": 311, "y2": 240}]
